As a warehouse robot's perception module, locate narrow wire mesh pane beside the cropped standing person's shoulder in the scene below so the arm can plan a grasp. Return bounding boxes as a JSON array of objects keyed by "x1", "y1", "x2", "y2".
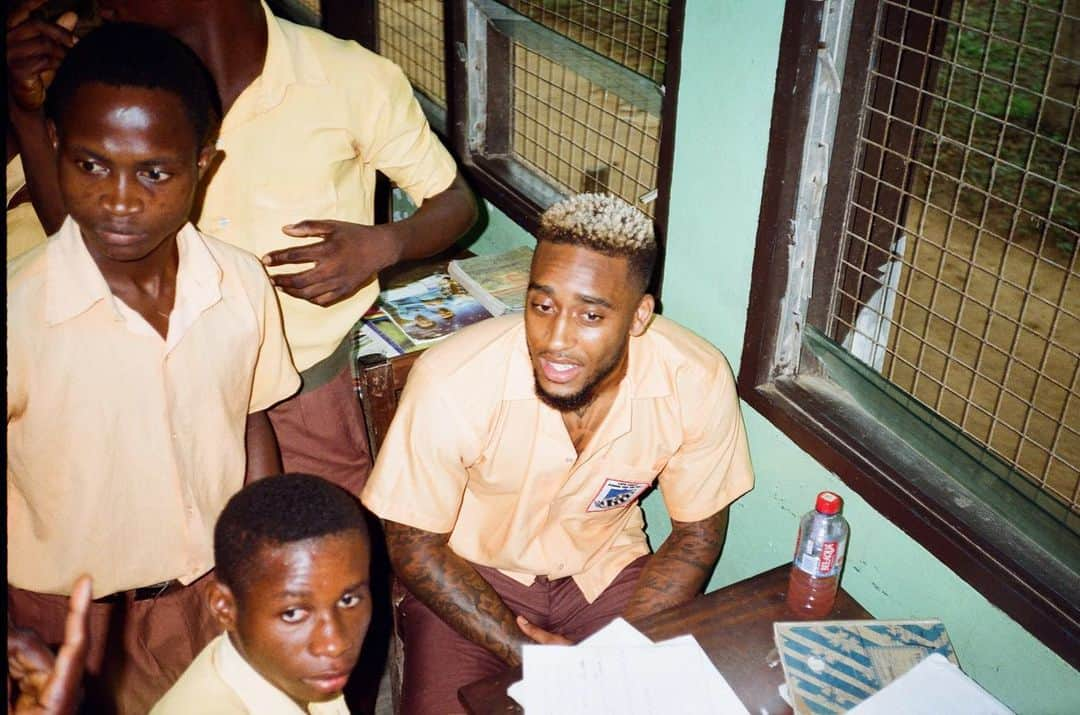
[{"x1": 378, "y1": 0, "x2": 446, "y2": 109}]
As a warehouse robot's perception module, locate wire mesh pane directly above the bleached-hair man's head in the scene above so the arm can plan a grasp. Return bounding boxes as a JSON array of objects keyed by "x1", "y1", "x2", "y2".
[{"x1": 513, "y1": 44, "x2": 660, "y2": 216}]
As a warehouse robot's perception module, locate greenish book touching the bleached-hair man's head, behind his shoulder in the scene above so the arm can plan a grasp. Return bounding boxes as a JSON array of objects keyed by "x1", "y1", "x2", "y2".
[{"x1": 447, "y1": 246, "x2": 532, "y2": 315}]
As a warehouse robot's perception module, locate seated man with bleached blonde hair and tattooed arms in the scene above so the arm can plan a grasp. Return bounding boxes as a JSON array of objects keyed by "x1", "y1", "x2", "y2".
[{"x1": 362, "y1": 194, "x2": 754, "y2": 713}]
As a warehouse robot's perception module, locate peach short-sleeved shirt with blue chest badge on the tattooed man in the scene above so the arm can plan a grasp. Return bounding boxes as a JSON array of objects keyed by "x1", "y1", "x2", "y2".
[{"x1": 362, "y1": 315, "x2": 754, "y2": 602}]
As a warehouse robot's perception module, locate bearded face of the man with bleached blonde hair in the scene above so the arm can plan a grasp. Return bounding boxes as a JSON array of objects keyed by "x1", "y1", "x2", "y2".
[{"x1": 525, "y1": 241, "x2": 652, "y2": 412}]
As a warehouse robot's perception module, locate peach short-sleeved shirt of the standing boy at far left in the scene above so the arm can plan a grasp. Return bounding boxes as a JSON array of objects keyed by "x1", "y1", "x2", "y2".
[{"x1": 8, "y1": 217, "x2": 299, "y2": 597}]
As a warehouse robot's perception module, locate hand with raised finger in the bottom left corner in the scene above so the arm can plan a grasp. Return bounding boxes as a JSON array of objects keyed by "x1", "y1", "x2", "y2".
[{"x1": 8, "y1": 576, "x2": 91, "y2": 715}]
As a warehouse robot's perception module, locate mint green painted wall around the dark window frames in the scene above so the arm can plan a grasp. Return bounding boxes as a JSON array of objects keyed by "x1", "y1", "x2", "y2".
[{"x1": 473, "y1": 0, "x2": 1080, "y2": 714}]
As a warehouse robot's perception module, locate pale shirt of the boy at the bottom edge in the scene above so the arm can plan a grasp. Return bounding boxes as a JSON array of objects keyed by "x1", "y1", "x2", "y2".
[{"x1": 150, "y1": 633, "x2": 349, "y2": 715}]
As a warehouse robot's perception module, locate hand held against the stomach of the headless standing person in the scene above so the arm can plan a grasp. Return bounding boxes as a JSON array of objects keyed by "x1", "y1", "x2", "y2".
[{"x1": 262, "y1": 220, "x2": 401, "y2": 307}]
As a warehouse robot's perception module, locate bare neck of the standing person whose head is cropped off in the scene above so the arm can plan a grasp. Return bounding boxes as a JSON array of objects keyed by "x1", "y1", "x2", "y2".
[{"x1": 176, "y1": 2, "x2": 267, "y2": 112}]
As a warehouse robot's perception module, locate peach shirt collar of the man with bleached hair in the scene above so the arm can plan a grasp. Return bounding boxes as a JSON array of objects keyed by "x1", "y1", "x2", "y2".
[{"x1": 503, "y1": 316, "x2": 672, "y2": 400}]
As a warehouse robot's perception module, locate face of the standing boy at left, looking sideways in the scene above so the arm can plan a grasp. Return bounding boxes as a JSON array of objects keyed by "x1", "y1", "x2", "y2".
[{"x1": 50, "y1": 82, "x2": 212, "y2": 265}]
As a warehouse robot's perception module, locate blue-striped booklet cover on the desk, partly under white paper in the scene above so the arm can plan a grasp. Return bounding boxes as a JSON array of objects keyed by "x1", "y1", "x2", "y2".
[{"x1": 773, "y1": 620, "x2": 958, "y2": 715}]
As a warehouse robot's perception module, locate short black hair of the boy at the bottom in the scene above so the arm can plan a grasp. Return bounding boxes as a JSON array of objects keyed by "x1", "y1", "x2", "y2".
[{"x1": 214, "y1": 474, "x2": 369, "y2": 595}]
